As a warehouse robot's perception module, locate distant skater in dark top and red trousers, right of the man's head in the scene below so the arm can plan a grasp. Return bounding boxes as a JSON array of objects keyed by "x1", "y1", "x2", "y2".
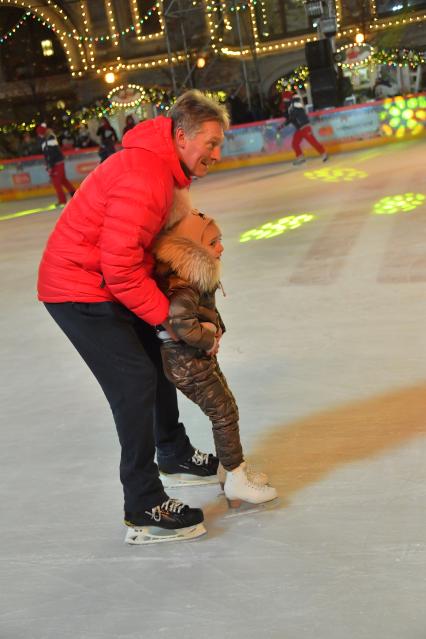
[{"x1": 280, "y1": 91, "x2": 328, "y2": 164}]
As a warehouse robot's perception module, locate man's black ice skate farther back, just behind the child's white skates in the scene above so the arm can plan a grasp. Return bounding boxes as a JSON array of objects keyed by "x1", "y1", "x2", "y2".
[{"x1": 159, "y1": 448, "x2": 219, "y2": 488}]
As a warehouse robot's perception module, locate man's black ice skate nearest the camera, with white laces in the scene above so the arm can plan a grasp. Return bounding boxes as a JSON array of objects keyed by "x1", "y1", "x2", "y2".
[{"x1": 124, "y1": 499, "x2": 207, "y2": 545}]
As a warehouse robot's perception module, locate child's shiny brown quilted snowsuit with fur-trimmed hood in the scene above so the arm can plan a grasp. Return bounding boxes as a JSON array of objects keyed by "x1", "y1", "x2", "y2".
[{"x1": 154, "y1": 226, "x2": 243, "y2": 470}]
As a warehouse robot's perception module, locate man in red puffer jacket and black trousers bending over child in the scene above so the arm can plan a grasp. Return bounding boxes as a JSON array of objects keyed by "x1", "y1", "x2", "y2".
[{"x1": 38, "y1": 91, "x2": 229, "y2": 543}]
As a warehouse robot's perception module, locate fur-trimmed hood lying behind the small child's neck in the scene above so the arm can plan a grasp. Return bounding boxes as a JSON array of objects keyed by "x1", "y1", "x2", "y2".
[{"x1": 153, "y1": 229, "x2": 220, "y2": 293}]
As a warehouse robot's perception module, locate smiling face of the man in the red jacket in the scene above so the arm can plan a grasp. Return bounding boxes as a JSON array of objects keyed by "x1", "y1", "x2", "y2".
[{"x1": 175, "y1": 120, "x2": 225, "y2": 177}]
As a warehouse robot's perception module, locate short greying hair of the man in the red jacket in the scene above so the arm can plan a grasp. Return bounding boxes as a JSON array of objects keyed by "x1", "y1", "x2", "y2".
[{"x1": 168, "y1": 89, "x2": 229, "y2": 137}]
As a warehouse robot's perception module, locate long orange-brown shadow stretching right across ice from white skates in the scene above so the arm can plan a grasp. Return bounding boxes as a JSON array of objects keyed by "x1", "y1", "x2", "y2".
[{"x1": 205, "y1": 385, "x2": 426, "y2": 519}]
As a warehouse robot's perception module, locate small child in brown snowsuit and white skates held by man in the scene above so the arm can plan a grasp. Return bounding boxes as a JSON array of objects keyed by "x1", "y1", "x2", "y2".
[{"x1": 153, "y1": 210, "x2": 276, "y2": 510}]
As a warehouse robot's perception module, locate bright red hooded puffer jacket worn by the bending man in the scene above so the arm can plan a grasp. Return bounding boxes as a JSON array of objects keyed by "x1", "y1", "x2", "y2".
[{"x1": 38, "y1": 117, "x2": 190, "y2": 324}]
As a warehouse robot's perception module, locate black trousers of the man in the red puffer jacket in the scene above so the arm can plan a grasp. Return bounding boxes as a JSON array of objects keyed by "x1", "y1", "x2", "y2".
[{"x1": 45, "y1": 302, "x2": 194, "y2": 513}]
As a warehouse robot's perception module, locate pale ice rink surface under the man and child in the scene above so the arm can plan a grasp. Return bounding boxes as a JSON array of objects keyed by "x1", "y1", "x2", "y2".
[{"x1": 0, "y1": 141, "x2": 426, "y2": 639}]
